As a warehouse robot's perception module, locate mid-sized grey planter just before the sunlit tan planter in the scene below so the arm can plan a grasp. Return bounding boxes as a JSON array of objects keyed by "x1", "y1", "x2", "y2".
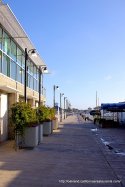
[{"x1": 43, "y1": 121, "x2": 52, "y2": 136}]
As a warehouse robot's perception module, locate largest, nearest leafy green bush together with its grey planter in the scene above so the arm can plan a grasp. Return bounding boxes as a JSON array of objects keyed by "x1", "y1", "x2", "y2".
[{"x1": 11, "y1": 102, "x2": 38, "y2": 147}]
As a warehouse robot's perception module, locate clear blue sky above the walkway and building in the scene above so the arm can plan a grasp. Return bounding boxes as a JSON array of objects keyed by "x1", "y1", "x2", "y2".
[{"x1": 4, "y1": 0, "x2": 125, "y2": 109}]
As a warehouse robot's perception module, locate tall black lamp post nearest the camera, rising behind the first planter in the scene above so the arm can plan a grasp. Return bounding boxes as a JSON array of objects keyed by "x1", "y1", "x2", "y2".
[{"x1": 24, "y1": 48, "x2": 36, "y2": 103}]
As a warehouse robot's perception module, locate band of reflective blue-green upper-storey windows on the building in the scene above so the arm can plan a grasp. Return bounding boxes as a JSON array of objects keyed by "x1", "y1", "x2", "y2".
[{"x1": 0, "y1": 27, "x2": 39, "y2": 92}]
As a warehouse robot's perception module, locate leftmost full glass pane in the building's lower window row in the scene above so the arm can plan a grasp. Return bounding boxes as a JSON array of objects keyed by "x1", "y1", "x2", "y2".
[{"x1": 2, "y1": 54, "x2": 10, "y2": 76}]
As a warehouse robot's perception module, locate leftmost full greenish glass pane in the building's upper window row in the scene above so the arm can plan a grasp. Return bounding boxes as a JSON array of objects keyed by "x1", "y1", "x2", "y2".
[{"x1": 3, "y1": 32, "x2": 10, "y2": 55}]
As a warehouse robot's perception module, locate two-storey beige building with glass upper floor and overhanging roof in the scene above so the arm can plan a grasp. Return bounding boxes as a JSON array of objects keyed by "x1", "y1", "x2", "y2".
[{"x1": 0, "y1": 2, "x2": 46, "y2": 142}]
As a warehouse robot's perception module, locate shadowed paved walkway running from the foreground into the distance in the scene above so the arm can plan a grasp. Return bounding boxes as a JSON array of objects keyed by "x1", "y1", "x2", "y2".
[{"x1": 0, "y1": 115, "x2": 125, "y2": 187}]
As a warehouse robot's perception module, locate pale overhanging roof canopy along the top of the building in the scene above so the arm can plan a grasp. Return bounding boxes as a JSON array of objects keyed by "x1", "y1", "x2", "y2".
[{"x1": 0, "y1": 2, "x2": 45, "y2": 66}]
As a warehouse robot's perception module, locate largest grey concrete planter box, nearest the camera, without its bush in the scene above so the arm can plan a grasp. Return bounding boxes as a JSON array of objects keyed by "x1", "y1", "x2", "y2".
[{"x1": 24, "y1": 126, "x2": 38, "y2": 147}]
